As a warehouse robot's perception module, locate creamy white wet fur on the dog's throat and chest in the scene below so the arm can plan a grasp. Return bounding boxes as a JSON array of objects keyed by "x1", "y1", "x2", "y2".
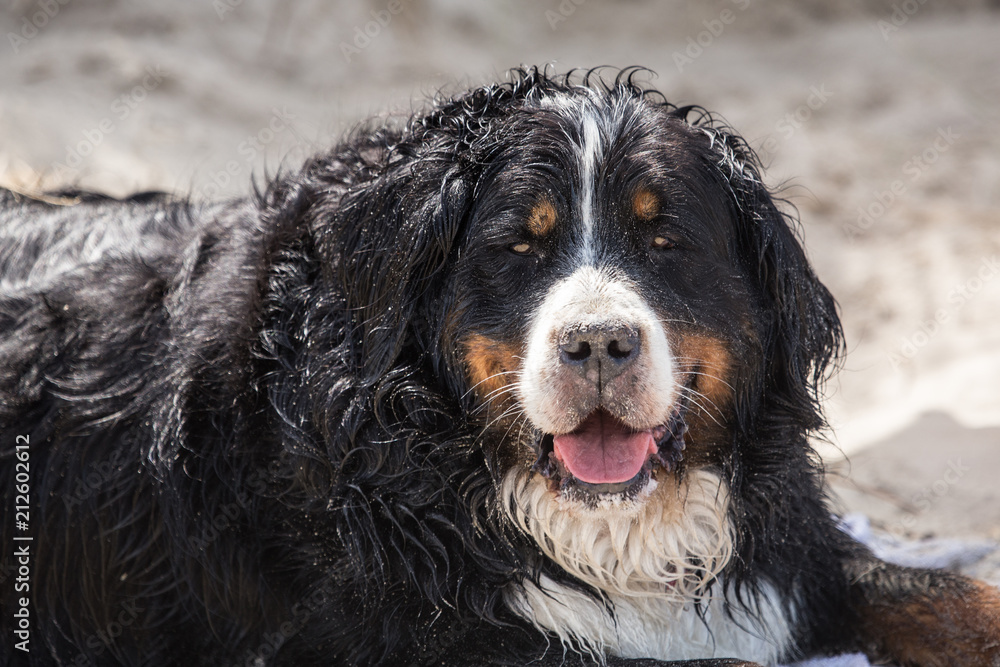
[{"x1": 504, "y1": 471, "x2": 791, "y2": 664}]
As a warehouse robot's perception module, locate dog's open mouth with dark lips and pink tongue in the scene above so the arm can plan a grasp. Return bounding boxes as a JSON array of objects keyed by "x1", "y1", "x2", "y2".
[{"x1": 532, "y1": 400, "x2": 687, "y2": 498}]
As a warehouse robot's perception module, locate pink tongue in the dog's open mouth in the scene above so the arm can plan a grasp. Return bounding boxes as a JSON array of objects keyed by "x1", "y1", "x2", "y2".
[{"x1": 552, "y1": 411, "x2": 656, "y2": 484}]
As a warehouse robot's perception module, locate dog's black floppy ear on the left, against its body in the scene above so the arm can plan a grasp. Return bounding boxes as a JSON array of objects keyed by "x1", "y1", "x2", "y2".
[{"x1": 334, "y1": 157, "x2": 468, "y2": 380}]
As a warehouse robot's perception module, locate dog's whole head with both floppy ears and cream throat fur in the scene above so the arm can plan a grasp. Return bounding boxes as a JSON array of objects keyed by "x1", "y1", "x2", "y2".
[{"x1": 324, "y1": 65, "x2": 840, "y2": 600}]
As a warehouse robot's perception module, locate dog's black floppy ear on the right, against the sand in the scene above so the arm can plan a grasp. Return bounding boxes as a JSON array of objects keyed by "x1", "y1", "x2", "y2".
[{"x1": 701, "y1": 113, "x2": 843, "y2": 429}]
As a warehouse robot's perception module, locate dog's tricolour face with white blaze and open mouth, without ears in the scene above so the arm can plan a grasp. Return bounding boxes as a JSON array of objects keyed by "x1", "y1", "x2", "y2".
[{"x1": 459, "y1": 94, "x2": 760, "y2": 506}]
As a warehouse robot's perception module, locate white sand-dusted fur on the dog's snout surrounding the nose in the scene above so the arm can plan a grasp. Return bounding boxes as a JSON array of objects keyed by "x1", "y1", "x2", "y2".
[{"x1": 518, "y1": 266, "x2": 678, "y2": 434}]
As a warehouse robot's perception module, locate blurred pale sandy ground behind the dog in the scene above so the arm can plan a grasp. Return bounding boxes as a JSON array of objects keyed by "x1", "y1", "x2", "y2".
[{"x1": 0, "y1": 0, "x2": 1000, "y2": 568}]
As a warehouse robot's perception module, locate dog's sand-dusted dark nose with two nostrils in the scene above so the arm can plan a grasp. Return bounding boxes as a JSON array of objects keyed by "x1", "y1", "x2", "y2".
[{"x1": 559, "y1": 323, "x2": 639, "y2": 390}]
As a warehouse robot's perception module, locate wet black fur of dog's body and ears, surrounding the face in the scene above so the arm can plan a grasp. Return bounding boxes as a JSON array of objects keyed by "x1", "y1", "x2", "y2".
[{"x1": 0, "y1": 69, "x2": 1000, "y2": 667}]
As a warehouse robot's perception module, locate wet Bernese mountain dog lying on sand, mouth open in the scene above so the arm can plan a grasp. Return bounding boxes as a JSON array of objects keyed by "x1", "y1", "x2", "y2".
[{"x1": 0, "y1": 68, "x2": 1000, "y2": 667}]
